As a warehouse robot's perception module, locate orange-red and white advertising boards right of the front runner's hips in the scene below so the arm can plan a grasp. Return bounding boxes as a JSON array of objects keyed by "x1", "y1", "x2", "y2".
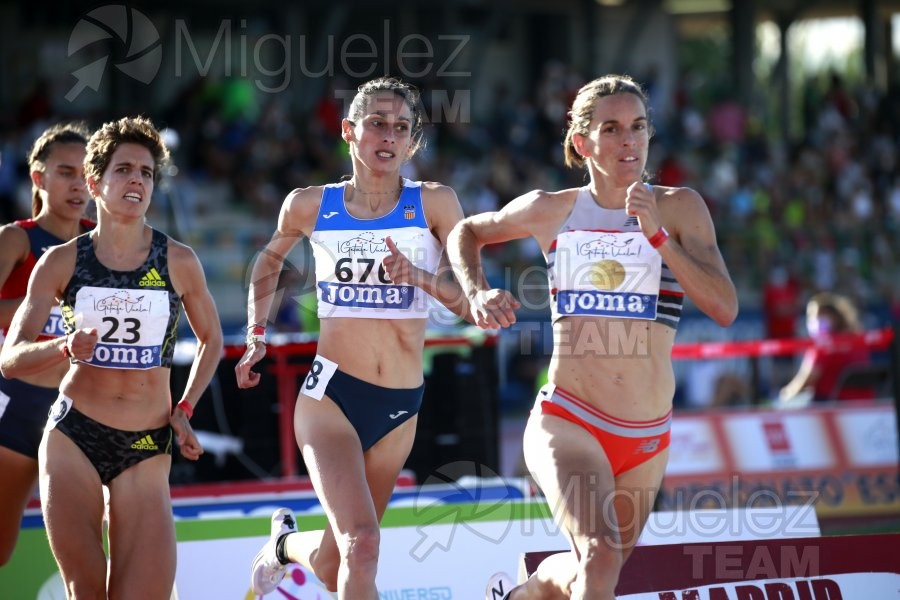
[{"x1": 658, "y1": 404, "x2": 900, "y2": 519}]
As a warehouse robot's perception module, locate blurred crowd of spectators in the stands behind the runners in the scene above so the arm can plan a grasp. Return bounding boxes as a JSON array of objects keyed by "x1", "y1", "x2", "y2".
[{"x1": 0, "y1": 63, "x2": 900, "y2": 337}]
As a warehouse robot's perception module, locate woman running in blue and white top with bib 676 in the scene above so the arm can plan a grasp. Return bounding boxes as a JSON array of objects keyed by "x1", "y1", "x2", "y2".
[{"x1": 235, "y1": 78, "x2": 472, "y2": 600}]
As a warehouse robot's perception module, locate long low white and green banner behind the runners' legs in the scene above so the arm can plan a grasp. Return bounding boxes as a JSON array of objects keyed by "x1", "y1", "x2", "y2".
[{"x1": 7, "y1": 494, "x2": 819, "y2": 600}]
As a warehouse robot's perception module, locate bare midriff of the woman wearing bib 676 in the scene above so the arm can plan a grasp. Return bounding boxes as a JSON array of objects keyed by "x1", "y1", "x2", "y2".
[{"x1": 317, "y1": 317, "x2": 425, "y2": 389}]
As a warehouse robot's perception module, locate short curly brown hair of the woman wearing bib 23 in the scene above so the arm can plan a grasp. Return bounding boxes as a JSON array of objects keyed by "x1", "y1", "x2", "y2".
[{"x1": 84, "y1": 117, "x2": 169, "y2": 183}]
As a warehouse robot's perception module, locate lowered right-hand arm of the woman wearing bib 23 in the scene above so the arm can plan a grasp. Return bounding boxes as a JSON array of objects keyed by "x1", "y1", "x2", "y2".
[{"x1": 169, "y1": 240, "x2": 222, "y2": 460}]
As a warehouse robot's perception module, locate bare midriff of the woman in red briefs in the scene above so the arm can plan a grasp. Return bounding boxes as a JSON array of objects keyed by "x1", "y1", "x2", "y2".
[{"x1": 549, "y1": 317, "x2": 675, "y2": 421}]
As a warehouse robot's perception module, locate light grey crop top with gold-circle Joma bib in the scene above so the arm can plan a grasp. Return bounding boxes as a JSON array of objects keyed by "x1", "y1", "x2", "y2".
[{"x1": 547, "y1": 187, "x2": 684, "y2": 329}]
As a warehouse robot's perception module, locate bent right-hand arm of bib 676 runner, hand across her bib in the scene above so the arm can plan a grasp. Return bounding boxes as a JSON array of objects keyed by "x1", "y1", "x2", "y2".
[{"x1": 383, "y1": 183, "x2": 473, "y2": 322}]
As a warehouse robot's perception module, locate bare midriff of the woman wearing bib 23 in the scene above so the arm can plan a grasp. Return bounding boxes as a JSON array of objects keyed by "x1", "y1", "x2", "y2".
[{"x1": 60, "y1": 363, "x2": 172, "y2": 431}]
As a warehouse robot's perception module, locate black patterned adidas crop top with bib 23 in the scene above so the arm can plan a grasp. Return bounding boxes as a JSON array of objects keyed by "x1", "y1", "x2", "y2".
[{"x1": 61, "y1": 229, "x2": 181, "y2": 369}]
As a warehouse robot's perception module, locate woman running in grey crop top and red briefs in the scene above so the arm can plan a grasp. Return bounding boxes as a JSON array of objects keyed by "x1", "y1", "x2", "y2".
[{"x1": 448, "y1": 75, "x2": 737, "y2": 600}]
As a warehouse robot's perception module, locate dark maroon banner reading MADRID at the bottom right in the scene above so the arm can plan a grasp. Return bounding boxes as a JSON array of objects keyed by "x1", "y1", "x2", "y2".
[{"x1": 520, "y1": 534, "x2": 900, "y2": 600}]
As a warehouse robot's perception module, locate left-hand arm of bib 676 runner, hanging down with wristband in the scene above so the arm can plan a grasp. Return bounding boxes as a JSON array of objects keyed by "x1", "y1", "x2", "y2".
[{"x1": 234, "y1": 186, "x2": 322, "y2": 388}]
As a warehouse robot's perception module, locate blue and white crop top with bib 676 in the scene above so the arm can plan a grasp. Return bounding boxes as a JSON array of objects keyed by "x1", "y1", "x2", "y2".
[{"x1": 309, "y1": 179, "x2": 442, "y2": 319}]
